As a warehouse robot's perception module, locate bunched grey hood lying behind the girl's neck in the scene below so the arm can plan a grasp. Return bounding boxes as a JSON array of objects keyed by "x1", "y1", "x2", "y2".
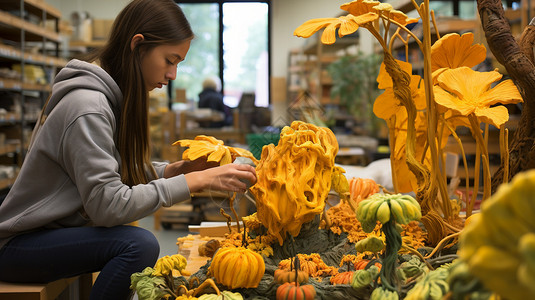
[{"x1": 43, "y1": 59, "x2": 123, "y2": 119}]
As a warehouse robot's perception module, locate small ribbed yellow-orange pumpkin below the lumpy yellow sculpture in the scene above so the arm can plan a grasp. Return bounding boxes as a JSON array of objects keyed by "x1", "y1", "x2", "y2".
[{"x1": 209, "y1": 247, "x2": 266, "y2": 289}]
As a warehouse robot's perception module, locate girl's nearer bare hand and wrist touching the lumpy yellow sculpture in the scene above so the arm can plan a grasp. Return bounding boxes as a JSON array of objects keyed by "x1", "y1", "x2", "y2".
[{"x1": 185, "y1": 164, "x2": 256, "y2": 193}]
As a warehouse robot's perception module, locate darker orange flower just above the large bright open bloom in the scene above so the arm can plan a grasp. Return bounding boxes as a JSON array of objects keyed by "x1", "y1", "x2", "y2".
[{"x1": 431, "y1": 32, "x2": 487, "y2": 77}]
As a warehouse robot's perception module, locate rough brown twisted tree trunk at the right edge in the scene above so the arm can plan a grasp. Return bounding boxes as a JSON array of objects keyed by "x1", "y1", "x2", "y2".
[{"x1": 477, "y1": 0, "x2": 535, "y2": 192}]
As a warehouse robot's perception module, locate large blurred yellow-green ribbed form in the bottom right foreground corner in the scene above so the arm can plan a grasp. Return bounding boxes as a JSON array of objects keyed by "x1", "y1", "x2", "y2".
[{"x1": 458, "y1": 170, "x2": 535, "y2": 300}]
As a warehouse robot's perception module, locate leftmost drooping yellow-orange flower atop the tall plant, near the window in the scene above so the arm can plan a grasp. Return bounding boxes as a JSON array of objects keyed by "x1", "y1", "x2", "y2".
[{"x1": 294, "y1": 13, "x2": 378, "y2": 45}]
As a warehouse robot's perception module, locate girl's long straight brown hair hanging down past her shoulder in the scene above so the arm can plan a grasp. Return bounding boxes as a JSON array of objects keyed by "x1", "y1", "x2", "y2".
[{"x1": 86, "y1": 0, "x2": 194, "y2": 186}]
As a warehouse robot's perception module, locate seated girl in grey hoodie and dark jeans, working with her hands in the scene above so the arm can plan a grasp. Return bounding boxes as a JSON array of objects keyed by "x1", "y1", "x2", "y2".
[{"x1": 0, "y1": 0, "x2": 256, "y2": 300}]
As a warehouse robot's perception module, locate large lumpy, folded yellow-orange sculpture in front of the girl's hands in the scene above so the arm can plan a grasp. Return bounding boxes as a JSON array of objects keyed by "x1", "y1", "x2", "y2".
[{"x1": 251, "y1": 121, "x2": 338, "y2": 245}]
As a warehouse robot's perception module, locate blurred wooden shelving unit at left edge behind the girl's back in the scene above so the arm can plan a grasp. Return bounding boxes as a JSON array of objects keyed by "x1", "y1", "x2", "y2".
[{"x1": 0, "y1": 0, "x2": 67, "y2": 194}]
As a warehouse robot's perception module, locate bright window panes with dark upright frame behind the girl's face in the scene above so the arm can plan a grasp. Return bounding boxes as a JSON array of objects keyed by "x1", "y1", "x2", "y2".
[{"x1": 173, "y1": 0, "x2": 269, "y2": 107}]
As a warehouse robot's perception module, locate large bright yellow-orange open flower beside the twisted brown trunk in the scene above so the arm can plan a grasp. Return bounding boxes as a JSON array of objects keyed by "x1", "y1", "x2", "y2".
[{"x1": 434, "y1": 67, "x2": 522, "y2": 128}]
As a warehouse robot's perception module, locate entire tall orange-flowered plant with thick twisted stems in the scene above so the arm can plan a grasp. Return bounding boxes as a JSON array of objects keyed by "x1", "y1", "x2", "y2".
[{"x1": 294, "y1": 0, "x2": 522, "y2": 245}]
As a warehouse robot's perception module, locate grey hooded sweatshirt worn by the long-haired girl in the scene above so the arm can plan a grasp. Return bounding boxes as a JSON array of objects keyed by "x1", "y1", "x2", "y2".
[{"x1": 0, "y1": 60, "x2": 190, "y2": 248}]
